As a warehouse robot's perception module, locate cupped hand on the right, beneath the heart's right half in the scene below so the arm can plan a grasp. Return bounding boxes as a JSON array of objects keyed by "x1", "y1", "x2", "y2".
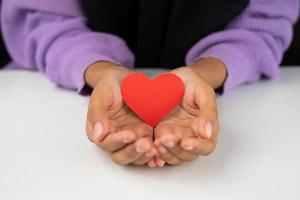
[{"x1": 154, "y1": 67, "x2": 219, "y2": 166}]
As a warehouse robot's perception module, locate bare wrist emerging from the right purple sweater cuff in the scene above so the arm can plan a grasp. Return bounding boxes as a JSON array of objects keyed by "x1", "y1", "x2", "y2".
[{"x1": 189, "y1": 58, "x2": 227, "y2": 89}]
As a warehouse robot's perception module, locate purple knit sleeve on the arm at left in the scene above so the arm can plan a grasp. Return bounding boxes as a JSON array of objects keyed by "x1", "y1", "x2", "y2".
[{"x1": 2, "y1": 0, "x2": 134, "y2": 94}]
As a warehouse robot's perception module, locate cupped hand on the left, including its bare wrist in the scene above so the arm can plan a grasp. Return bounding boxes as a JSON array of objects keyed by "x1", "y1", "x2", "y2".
[{"x1": 85, "y1": 62, "x2": 157, "y2": 165}]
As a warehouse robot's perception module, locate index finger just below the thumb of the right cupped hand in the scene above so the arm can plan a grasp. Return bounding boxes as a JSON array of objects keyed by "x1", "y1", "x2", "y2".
[{"x1": 180, "y1": 137, "x2": 216, "y2": 155}]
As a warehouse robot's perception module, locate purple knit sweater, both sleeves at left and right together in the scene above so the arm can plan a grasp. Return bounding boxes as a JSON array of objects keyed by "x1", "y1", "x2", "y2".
[{"x1": 0, "y1": 0, "x2": 299, "y2": 92}]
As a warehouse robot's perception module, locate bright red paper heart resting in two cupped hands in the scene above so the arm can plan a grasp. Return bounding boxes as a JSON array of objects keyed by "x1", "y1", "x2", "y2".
[{"x1": 122, "y1": 72, "x2": 184, "y2": 127}]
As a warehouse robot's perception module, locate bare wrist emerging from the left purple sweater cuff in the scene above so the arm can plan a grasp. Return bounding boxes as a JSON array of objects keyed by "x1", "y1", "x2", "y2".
[{"x1": 84, "y1": 61, "x2": 130, "y2": 88}]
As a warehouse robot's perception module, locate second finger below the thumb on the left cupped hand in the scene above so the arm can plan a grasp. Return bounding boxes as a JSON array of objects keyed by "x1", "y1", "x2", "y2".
[{"x1": 111, "y1": 138, "x2": 151, "y2": 165}]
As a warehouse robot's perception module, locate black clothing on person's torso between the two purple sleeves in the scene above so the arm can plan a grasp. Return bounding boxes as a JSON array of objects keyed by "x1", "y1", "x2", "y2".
[{"x1": 81, "y1": 0, "x2": 249, "y2": 68}]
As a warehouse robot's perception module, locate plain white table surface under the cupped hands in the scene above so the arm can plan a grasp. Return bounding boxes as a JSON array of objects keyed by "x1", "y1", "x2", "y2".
[{"x1": 0, "y1": 68, "x2": 300, "y2": 200}]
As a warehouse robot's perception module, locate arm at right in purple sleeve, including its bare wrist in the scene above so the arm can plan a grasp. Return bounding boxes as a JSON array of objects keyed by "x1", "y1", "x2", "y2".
[{"x1": 186, "y1": 0, "x2": 299, "y2": 91}]
